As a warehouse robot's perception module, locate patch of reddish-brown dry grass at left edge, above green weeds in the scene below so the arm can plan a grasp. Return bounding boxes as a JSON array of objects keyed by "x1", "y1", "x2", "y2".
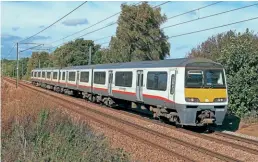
[{"x1": 1, "y1": 82, "x2": 56, "y2": 130}]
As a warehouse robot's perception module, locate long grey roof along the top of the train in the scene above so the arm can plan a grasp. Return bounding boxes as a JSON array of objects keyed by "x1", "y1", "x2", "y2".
[{"x1": 32, "y1": 58, "x2": 222, "y2": 70}]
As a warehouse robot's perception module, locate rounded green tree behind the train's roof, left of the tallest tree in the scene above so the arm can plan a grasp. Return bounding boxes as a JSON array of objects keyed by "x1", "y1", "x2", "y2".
[{"x1": 53, "y1": 39, "x2": 100, "y2": 67}]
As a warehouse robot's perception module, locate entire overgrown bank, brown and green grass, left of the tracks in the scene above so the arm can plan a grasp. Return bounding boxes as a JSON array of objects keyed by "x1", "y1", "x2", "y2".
[{"x1": 1, "y1": 83, "x2": 129, "y2": 161}]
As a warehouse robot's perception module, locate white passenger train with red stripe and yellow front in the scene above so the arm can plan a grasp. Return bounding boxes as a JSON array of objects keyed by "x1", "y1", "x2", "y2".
[{"x1": 31, "y1": 58, "x2": 228, "y2": 127}]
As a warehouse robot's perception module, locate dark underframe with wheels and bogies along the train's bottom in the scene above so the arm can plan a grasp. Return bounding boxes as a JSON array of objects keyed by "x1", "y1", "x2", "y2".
[{"x1": 32, "y1": 81, "x2": 222, "y2": 127}]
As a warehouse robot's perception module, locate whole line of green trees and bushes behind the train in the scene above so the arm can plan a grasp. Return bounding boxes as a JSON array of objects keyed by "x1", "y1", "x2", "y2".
[{"x1": 2, "y1": 3, "x2": 258, "y2": 116}]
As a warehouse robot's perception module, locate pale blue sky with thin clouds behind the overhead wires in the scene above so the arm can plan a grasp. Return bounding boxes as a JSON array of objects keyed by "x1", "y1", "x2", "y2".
[{"x1": 1, "y1": 1, "x2": 258, "y2": 59}]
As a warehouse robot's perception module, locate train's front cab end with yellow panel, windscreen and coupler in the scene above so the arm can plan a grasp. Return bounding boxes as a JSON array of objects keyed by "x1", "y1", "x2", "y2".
[{"x1": 176, "y1": 63, "x2": 228, "y2": 126}]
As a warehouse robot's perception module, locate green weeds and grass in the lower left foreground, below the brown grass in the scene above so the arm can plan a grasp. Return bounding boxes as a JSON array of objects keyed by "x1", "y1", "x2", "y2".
[{"x1": 2, "y1": 110, "x2": 129, "y2": 162}]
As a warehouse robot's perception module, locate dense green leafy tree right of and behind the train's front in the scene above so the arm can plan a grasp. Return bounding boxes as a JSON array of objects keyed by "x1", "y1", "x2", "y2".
[{"x1": 188, "y1": 29, "x2": 258, "y2": 117}]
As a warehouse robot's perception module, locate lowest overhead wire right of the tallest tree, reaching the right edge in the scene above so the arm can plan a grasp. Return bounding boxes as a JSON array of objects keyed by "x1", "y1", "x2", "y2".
[{"x1": 168, "y1": 17, "x2": 258, "y2": 39}]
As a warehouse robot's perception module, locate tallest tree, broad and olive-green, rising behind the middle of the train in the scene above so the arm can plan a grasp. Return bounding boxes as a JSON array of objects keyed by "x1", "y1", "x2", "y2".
[{"x1": 105, "y1": 2, "x2": 170, "y2": 62}]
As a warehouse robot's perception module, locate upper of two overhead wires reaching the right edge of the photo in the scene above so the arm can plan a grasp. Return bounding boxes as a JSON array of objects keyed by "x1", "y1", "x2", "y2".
[{"x1": 161, "y1": 3, "x2": 258, "y2": 29}]
